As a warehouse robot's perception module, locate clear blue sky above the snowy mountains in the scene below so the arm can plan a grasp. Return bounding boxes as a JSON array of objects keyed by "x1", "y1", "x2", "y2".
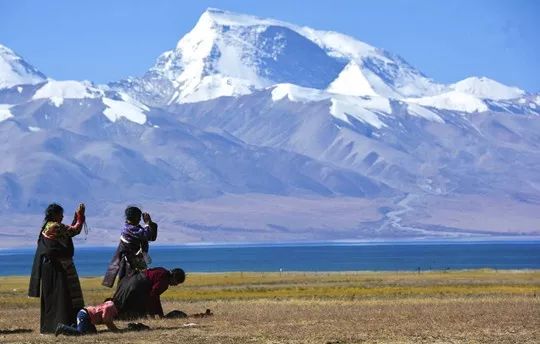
[{"x1": 0, "y1": 0, "x2": 540, "y2": 92}]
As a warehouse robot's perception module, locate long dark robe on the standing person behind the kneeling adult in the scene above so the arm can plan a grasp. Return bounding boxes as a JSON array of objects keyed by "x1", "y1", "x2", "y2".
[{"x1": 101, "y1": 222, "x2": 158, "y2": 288}]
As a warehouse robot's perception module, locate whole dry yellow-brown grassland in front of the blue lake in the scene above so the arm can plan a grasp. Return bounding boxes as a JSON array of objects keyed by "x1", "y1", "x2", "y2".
[{"x1": 0, "y1": 270, "x2": 540, "y2": 344}]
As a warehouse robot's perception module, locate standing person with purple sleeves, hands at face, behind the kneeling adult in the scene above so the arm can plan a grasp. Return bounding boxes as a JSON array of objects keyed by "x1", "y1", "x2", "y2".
[{"x1": 102, "y1": 206, "x2": 158, "y2": 288}]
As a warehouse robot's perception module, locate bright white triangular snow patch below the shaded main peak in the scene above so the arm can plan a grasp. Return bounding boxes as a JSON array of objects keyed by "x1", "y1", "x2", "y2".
[{"x1": 327, "y1": 62, "x2": 377, "y2": 96}]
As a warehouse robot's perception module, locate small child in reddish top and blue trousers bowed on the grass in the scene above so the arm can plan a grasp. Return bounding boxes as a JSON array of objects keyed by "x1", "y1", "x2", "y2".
[{"x1": 54, "y1": 299, "x2": 118, "y2": 336}]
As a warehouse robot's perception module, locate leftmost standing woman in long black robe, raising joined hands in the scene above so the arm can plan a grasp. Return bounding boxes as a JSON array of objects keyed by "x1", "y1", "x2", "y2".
[{"x1": 28, "y1": 203, "x2": 85, "y2": 333}]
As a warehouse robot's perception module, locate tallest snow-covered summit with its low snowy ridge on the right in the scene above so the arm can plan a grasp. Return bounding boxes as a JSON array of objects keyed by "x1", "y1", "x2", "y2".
[{"x1": 111, "y1": 8, "x2": 524, "y2": 112}]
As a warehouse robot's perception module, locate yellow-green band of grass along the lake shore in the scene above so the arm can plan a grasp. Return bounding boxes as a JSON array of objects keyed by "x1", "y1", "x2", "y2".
[{"x1": 0, "y1": 270, "x2": 540, "y2": 308}]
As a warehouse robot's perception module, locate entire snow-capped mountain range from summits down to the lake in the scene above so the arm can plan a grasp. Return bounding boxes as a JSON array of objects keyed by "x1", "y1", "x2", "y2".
[{"x1": 0, "y1": 9, "x2": 540, "y2": 245}]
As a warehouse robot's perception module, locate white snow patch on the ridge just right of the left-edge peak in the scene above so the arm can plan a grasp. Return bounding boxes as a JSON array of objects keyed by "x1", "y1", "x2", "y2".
[{"x1": 32, "y1": 80, "x2": 103, "y2": 107}]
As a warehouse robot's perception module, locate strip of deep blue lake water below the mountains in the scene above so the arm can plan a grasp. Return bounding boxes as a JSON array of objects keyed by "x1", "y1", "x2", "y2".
[{"x1": 0, "y1": 241, "x2": 540, "y2": 276}]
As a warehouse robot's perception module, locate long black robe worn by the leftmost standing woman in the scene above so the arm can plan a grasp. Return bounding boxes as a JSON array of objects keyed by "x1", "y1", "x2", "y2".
[{"x1": 28, "y1": 234, "x2": 84, "y2": 333}]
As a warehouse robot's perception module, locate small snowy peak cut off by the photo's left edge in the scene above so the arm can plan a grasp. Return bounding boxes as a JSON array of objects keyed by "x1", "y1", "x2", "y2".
[{"x1": 0, "y1": 44, "x2": 47, "y2": 89}]
